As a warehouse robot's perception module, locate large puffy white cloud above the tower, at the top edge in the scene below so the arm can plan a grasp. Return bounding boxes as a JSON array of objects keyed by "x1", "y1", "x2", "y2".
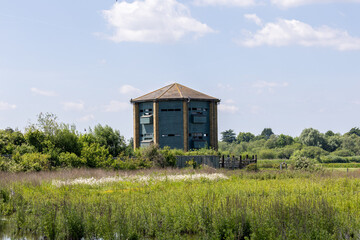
[{"x1": 103, "y1": 0, "x2": 214, "y2": 42}]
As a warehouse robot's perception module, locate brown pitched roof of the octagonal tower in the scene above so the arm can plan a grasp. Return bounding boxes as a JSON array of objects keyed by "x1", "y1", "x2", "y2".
[{"x1": 131, "y1": 83, "x2": 220, "y2": 102}]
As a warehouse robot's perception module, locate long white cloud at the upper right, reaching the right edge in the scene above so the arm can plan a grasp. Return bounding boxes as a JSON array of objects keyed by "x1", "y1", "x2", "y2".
[{"x1": 238, "y1": 19, "x2": 360, "y2": 51}]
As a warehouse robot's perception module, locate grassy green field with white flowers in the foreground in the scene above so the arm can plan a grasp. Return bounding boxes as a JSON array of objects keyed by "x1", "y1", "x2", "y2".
[{"x1": 0, "y1": 169, "x2": 360, "y2": 239}]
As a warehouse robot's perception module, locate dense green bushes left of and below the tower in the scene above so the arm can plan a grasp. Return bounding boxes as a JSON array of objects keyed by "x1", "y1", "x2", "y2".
[{"x1": 0, "y1": 113, "x2": 217, "y2": 172}]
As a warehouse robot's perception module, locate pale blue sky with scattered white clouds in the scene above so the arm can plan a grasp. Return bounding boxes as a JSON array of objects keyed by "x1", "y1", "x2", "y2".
[{"x1": 0, "y1": 0, "x2": 360, "y2": 139}]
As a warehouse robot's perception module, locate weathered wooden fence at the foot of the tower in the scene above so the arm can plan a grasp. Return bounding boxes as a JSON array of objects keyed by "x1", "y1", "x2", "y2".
[{"x1": 176, "y1": 155, "x2": 257, "y2": 169}]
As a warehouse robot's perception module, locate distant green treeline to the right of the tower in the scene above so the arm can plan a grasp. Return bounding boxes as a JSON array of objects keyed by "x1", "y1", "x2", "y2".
[{"x1": 219, "y1": 127, "x2": 360, "y2": 162}]
